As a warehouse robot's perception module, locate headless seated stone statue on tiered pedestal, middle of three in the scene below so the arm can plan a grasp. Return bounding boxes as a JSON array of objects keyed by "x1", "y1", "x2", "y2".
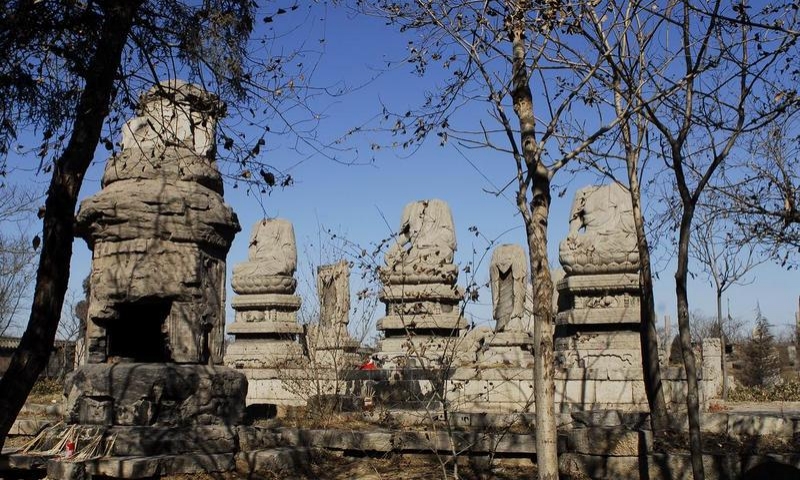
[{"x1": 378, "y1": 199, "x2": 466, "y2": 364}]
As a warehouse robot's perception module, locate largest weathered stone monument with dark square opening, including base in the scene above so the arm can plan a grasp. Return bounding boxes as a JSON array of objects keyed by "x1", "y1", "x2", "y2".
[{"x1": 72, "y1": 80, "x2": 247, "y2": 432}]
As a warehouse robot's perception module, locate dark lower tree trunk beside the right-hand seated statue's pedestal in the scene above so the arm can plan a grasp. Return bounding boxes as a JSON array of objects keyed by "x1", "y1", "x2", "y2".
[{"x1": 628, "y1": 170, "x2": 670, "y2": 437}]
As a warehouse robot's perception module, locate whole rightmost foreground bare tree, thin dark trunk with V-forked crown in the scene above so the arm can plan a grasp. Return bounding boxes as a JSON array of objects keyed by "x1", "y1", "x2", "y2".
[{"x1": 630, "y1": 0, "x2": 797, "y2": 479}]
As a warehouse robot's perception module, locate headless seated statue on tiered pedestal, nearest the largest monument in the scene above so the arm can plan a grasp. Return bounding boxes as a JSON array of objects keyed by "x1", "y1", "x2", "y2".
[{"x1": 225, "y1": 218, "x2": 303, "y2": 369}]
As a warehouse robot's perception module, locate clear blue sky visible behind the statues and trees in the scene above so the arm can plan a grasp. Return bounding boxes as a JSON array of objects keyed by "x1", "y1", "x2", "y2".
[{"x1": 3, "y1": 5, "x2": 800, "y2": 342}]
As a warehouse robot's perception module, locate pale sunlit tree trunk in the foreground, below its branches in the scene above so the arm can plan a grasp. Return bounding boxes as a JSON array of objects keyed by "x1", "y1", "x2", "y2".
[{"x1": 526, "y1": 169, "x2": 558, "y2": 480}]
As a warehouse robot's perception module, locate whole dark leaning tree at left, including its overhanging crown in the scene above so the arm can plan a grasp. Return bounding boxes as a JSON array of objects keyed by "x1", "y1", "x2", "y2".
[{"x1": 0, "y1": 0, "x2": 330, "y2": 450}]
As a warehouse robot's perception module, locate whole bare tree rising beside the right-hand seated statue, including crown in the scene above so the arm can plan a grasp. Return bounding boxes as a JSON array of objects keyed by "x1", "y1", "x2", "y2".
[{"x1": 581, "y1": 0, "x2": 683, "y2": 436}]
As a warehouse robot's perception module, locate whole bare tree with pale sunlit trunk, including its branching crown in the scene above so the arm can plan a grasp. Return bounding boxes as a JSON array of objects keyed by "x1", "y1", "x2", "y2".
[{"x1": 350, "y1": 1, "x2": 656, "y2": 479}]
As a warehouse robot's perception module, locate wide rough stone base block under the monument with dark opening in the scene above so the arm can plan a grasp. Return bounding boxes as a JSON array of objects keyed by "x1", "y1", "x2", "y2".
[{"x1": 65, "y1": 363, "x2": 247, "y2": 426}]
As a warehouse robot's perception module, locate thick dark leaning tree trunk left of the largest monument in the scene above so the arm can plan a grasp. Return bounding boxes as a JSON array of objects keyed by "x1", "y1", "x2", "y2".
[{"x1": 0, "y1": 0, "x2": 141, "y2": 446}]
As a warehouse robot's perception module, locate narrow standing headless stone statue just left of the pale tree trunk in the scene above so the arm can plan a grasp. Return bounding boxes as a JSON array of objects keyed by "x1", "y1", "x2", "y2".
[{"x1": 479, "y1": 244, "x2": 533, "y2": 366}]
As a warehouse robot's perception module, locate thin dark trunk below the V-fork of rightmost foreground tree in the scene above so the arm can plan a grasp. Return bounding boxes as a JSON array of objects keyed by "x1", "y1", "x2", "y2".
[{"x1": 675, "y1": 202, "x2": 705, "y2": 480}]
